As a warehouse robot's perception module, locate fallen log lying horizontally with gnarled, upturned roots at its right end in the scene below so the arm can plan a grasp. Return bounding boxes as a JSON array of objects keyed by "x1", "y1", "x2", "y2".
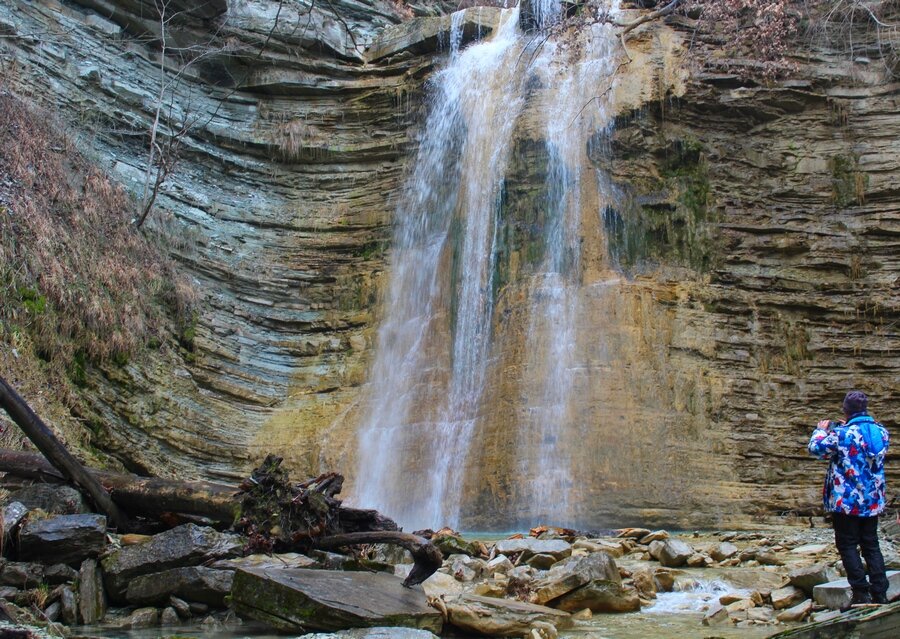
[{"x1": 0, "y1": 449, "x2": 443, "y2": 586}]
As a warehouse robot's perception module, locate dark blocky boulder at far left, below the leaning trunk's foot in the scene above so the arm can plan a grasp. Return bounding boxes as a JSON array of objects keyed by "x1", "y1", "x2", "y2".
[{"x1": 19, "y1": 515, "x2": 106, "y2": 564}]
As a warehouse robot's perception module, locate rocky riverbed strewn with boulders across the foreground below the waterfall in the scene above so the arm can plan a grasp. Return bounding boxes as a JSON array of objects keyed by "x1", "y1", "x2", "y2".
[{"x1": 0, "y1": 486, "x2": 900, "y2": 639}]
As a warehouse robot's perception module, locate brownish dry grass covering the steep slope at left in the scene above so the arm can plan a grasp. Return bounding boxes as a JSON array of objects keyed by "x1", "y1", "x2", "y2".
[{"x1": 0, "y1": 87, "x2": 194, "y2": 372}]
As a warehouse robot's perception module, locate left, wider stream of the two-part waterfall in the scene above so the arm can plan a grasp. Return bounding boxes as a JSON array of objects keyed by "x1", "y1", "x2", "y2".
[{"x1": 357, "y1": 11, "x2": 523, "y2": 526}]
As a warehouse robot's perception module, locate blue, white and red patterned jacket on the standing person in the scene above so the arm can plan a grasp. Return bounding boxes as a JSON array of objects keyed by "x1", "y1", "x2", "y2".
[{"x1": 809, "y1": 413, "x2": 890, "y2": 517}]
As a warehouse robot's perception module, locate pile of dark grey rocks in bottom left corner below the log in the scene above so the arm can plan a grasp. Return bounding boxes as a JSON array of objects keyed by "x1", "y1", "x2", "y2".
[{"x1": 0, "y1": 485, "x2": 243, "y2": 628}]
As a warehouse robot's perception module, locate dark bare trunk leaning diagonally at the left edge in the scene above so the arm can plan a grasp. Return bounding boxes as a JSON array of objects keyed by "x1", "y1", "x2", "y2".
[{"x1": 0, "y1": 377, "x2": 127, "y2": 528}]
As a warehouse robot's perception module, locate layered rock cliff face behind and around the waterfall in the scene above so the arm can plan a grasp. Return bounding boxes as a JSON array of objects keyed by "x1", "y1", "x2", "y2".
[{"x1": 0, "y1": 0, "x2": 900, "y2": 527}]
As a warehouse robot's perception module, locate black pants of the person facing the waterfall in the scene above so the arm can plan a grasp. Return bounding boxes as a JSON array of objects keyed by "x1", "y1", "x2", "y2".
[{"x1": 832, "y1": 513, "x2": 888, "y2": 594}]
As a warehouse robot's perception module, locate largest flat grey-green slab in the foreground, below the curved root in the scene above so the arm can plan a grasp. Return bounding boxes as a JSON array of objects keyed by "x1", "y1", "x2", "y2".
[{"x1": 231, "y1": 567, "x2": 443, "y2": 633}]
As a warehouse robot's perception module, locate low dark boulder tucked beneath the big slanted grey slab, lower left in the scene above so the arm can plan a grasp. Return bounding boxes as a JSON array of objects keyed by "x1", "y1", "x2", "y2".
[{"x1": 125, "y1": 566, "x2": 234, "y2": 608}]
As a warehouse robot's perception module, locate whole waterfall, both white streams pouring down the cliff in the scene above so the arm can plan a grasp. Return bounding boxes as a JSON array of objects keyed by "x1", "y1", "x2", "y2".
[{"x1": 354, "y1": 0, "x2": 615, "y2": 529}]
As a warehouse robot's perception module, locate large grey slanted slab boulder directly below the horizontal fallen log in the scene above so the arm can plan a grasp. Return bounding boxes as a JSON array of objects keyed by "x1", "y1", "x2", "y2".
[{"x1": 102, "y1": 524, "x2": 243, "y2": 601}]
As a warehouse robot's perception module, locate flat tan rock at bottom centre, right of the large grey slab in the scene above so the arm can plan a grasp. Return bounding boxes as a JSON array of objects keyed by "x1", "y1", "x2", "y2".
[{"x1": 444, "y1": 595, "x2": 573, "y2": 637}]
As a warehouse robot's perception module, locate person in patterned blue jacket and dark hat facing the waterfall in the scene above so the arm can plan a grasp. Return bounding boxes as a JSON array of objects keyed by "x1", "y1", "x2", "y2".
[{"x1": 809, "y1": 390, "x2": 890, "y2": 605}]
